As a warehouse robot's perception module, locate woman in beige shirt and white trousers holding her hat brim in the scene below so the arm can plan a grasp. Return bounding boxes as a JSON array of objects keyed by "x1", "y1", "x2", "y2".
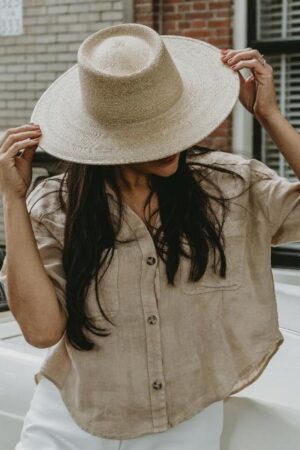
[{"x1": 0, "y1": 24, "x2": 300, "y2": 450}]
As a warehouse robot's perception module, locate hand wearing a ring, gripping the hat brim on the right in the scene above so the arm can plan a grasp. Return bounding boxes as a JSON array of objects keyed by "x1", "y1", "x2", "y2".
[{"x1": 221, "y1": 48, "x2": 279, "y2": 121}]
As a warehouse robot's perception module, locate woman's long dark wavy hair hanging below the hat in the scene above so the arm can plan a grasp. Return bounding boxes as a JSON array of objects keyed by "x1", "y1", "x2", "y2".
[{"x1": 31, "y1": 145, "x2": 243, "y2": 350}]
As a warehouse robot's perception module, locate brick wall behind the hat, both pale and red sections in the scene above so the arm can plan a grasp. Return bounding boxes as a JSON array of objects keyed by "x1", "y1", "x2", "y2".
[{"x1": 0, "y1": 0, "x2": 233, "y2": 150}]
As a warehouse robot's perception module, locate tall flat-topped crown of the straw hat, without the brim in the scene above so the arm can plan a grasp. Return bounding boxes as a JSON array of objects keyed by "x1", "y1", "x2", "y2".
[{"x1": 77, "y1": 23, "x2": 183, "y2": 124}]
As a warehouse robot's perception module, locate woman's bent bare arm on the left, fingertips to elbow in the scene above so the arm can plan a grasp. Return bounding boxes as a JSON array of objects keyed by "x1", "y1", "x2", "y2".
[{"x1": 0, "y1": 125, "x2": 66, "y2": 348}]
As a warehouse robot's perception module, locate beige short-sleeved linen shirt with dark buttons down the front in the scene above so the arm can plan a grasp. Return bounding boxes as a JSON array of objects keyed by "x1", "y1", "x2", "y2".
[{"x1": 0, "y1": 151, "x2": 300, "y2": 439}]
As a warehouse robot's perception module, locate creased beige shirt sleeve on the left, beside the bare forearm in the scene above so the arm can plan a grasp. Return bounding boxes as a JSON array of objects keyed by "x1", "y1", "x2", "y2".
[{"x1": 0, "y1": 178, "x2": 68, "y2": 317}]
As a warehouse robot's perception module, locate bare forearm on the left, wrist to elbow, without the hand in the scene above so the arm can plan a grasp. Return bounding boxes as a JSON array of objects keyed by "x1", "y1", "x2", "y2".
[{"x1": 3, "y1": 197, "x2": 62, "y2": 347}]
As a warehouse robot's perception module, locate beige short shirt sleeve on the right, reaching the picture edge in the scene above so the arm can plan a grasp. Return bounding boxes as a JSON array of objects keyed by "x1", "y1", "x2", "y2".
[{"x1": 250, "y1": 159, "x2": 300, "y2": 246}]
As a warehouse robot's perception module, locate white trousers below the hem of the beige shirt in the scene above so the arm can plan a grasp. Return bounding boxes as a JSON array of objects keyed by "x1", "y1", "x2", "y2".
[{"x1": 15, "y1": 377, "x2": 223, "y2": 450}]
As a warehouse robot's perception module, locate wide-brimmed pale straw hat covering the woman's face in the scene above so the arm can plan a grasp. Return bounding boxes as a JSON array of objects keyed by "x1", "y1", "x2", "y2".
[{"x1": 31, "y1": 23, "x2": 239, "y2": 164}]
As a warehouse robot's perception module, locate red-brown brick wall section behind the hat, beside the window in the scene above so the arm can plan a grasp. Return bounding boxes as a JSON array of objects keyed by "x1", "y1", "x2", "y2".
[{"x1": 135, "y1": 0, "x2": 233, "y2": 150}]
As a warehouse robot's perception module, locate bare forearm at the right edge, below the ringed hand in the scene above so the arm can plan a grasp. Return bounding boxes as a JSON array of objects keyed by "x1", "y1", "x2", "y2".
[{"x1": 258, "y1": 111, "x2": 300, "y2": 179}]
